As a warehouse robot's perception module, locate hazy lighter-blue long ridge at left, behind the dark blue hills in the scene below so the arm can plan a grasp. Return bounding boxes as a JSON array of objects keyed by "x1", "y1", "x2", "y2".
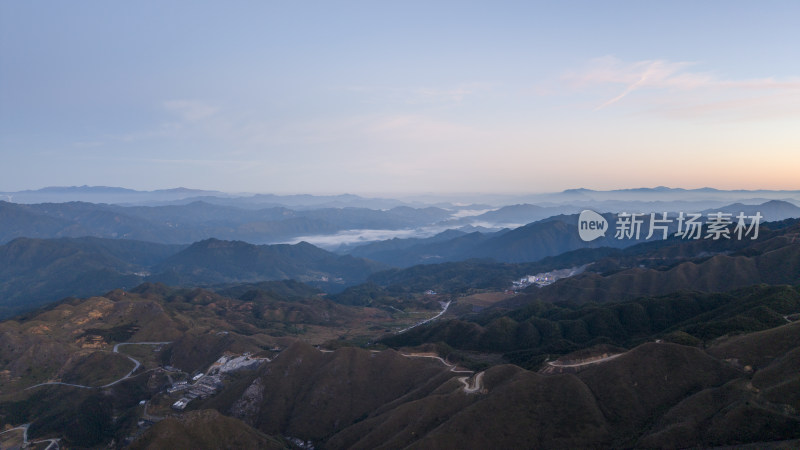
[{"x1": 0, "y1": 201, "x2": 451, "y2": 244}]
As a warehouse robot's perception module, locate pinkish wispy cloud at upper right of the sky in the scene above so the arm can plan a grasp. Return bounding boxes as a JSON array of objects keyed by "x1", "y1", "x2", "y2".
[{"x1": 562, "y1": 56, "x2": 800, "y2": 114}]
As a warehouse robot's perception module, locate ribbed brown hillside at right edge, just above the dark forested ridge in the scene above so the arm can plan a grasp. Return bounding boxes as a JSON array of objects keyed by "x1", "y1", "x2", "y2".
[{"x1": 498, "y1": 225, "x2": 800, "y2": 308}]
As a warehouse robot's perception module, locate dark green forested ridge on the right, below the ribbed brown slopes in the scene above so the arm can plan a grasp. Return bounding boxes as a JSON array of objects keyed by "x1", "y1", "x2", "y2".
[{"x1": 380, "y1": 285, "x2": 800, "y2": 368}]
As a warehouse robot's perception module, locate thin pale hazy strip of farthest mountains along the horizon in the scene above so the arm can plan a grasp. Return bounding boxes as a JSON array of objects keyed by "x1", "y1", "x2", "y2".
[{"x1": 0, "y1": 185, "x2": 800, "y2": 211}]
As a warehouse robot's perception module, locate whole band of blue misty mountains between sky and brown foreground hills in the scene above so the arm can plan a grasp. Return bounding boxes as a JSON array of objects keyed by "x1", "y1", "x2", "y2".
[{"x1": 0, "y1": 187, "x2": 800, "y2": 315}]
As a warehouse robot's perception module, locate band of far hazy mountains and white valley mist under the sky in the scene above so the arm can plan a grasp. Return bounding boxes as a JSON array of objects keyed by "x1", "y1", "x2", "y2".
[{"x1": 0, "y1": 187, "x2": 800, "y2": 251}]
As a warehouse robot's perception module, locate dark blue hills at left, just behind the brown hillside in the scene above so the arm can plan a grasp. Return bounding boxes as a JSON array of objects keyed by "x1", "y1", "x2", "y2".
[{"x1": 0, "y1": 238, "x2": 383, "y2": 317}]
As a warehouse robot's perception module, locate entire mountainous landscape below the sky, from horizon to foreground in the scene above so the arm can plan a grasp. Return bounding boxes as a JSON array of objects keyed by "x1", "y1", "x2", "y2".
[{"x1": 0, "y1": 187, "x2": 800, "y2": 448}]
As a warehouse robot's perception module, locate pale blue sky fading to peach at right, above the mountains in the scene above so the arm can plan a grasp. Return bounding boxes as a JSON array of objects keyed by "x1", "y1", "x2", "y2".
[{"x1": 0, "y1": 0, "x2": 800, "y2": 195}]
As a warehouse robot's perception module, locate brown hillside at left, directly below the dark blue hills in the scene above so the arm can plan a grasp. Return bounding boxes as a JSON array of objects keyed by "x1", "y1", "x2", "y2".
[{"x1": 0, "y1": 284, "x2": 438, "y2": 394}]
